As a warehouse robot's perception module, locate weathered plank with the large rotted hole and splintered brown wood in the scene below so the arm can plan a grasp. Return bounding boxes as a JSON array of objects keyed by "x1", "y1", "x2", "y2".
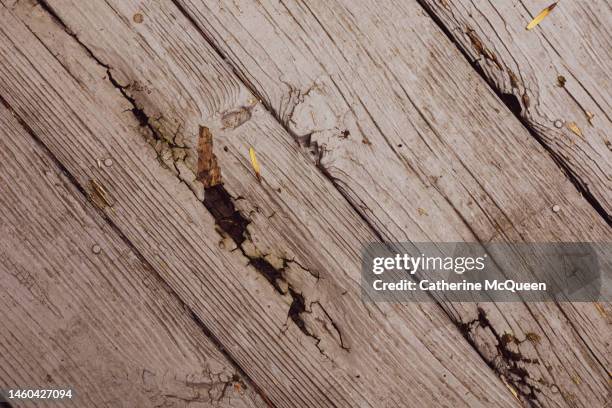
[{"x1": 0, "y1": 1, "x2": 517, "y2": 407}]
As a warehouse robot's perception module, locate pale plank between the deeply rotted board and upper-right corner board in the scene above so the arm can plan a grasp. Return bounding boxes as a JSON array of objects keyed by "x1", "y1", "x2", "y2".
[{"x1": 165, "y1": 0, "x2": 611, "y2": 406}]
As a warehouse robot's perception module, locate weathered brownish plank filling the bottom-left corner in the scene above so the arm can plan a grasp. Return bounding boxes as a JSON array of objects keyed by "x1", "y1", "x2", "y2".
[{"x1": 0, "y1": 106, "x2": 266, "y2": 408}]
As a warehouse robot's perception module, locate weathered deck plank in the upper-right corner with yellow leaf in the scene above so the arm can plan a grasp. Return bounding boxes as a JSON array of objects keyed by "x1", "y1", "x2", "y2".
[{"x1": 421, "y1": 0, "x2": 612, "y2": 220}]
